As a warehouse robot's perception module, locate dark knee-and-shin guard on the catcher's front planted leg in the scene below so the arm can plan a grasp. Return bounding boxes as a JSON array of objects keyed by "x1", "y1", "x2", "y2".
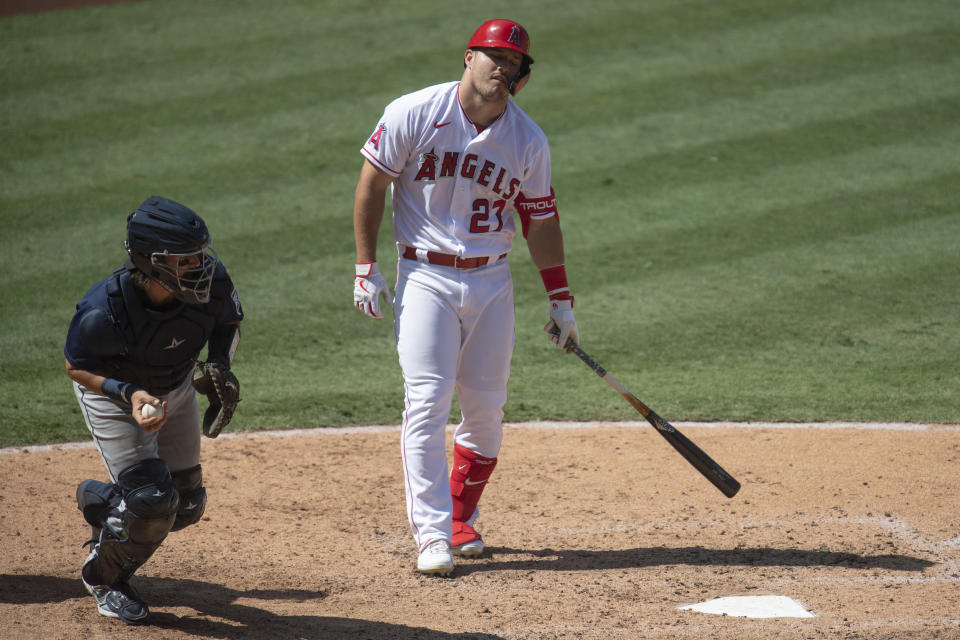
[{"x1": 97, "y1": 458, "x2": 180, "y2": 584}]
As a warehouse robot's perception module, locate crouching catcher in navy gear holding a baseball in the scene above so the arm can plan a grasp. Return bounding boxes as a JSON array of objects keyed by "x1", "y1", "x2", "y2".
[{"x1": 64, "y1": 196, "x2": 243, "y2": 624}]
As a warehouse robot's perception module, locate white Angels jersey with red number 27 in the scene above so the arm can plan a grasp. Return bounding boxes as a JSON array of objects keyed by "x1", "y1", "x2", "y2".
[{"x1": 362, "y1": 82, "x2": 556, "y2": 258}]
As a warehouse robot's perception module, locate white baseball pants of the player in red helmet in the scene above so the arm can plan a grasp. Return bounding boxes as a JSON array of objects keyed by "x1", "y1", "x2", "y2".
[{"x1": 394, "y1": 258, "x2": 514, "y2": 548}]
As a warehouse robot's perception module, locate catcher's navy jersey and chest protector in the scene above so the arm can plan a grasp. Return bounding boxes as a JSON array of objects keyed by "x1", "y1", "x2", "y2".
[{"x1": 63, "y1": 262, "x2": 243, "y2": 395}]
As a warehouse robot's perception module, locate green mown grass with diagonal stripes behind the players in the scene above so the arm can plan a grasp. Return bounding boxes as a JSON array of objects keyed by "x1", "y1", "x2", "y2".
[{"x1": 0, "y1": 0, "x2": 960, "y2": 446}]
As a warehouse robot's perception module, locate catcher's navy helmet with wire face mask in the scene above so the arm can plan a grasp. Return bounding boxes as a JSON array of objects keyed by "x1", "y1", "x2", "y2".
[{"x1": 125, "y1": 196, "x2": 219, "y2": 304}]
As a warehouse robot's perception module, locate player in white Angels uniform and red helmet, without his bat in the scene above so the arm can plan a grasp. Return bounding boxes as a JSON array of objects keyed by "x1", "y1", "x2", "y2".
[{"x1": 354, "y1": 20, "x2": 579, "y2": 575}]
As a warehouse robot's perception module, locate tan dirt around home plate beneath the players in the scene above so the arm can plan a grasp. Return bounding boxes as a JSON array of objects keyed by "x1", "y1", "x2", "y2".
[{"x1": 0, "y1": 425, "x2": 960, "y2": 640}]
